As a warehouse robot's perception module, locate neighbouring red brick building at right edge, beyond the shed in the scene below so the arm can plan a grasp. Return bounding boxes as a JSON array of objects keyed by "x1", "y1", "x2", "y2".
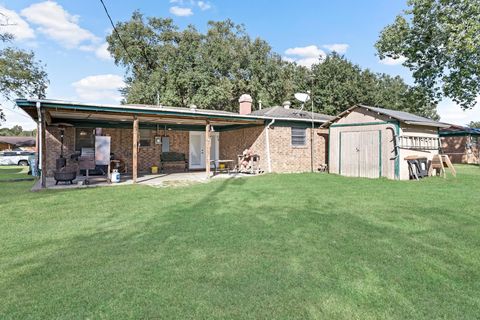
[{"x1": 440, "y1": 125, "x2": 480, "y2": 164}]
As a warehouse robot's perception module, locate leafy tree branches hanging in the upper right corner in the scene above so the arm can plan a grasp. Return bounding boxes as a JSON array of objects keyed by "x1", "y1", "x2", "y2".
[{"x1": 375, "y1": 0, "x2": 480, "y2": 109}]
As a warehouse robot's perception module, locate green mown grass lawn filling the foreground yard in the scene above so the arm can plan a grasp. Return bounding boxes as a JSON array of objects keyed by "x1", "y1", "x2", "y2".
[{"x1": 0, "y1": 166, "x2": 480, "y2": 319}]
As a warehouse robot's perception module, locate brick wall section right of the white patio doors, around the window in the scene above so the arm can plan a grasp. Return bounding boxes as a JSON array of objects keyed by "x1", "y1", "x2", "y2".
[{"x1": 220, "y1": 126, "x2": 328, "y2": 172}]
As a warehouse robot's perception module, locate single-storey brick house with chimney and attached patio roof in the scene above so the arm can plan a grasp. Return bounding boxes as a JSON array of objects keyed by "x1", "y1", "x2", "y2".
[{"x1": 16, "y1": 95, "x2": 332, "y2": 188}]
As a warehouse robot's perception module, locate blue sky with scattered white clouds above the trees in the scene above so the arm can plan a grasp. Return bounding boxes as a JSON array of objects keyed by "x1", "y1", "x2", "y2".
[{"x1": 0, "y1": 0, "x2": 480, "y2": 128}]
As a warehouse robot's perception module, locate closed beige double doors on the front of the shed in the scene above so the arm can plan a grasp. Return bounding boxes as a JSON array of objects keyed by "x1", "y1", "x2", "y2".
[{"x1": 339, "y1": 130, "x2": 382, "y2": 178}]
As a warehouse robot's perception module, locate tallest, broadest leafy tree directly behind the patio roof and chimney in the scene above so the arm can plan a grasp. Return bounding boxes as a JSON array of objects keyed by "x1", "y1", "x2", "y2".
[{"x1": 107, "y1": 12, "x2": 306, "y2": 111}]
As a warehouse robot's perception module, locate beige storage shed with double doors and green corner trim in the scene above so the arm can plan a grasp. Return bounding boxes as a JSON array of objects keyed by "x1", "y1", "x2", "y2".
[{"x1": 323, "y1": 105, "x2": 448, "y2": 180}]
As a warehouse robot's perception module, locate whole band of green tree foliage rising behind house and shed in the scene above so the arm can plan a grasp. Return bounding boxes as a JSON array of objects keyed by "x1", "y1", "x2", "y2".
[{"x1": 107, "y1": 12, "x2": 436, "y2": 117}]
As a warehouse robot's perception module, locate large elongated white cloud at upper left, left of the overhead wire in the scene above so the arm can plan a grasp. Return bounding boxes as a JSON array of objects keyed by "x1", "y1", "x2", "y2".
[{"x1": 21, "y1": 1, "x2": 100, "y2": 48}]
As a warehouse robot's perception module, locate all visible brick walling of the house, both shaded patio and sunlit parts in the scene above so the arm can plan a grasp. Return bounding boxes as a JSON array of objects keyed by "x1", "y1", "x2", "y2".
[{"x1": 46, "y1": 125, "x2": 328, "y2": 176}]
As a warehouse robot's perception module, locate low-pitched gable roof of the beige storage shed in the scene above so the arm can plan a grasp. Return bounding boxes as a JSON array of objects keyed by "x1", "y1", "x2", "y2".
[{"x1": 323, "y1": 104, "x2": 450, "y2": 128}]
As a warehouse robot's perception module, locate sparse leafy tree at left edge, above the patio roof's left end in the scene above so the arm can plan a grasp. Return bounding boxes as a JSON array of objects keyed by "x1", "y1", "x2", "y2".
[{"x1": 0, "y1": 9, "x2": 48, "y2": 120}]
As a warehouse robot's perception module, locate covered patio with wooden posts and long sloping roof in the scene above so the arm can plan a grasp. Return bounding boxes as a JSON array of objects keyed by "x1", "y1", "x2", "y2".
[{"x1": 17, "y1": 100, "x2": 265, "y2": 188}]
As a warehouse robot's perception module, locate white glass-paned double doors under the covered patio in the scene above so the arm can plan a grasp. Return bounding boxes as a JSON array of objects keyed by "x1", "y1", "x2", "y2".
[{"x1": 188, "y1": 131, "x2": 219, "y2": 169}]
